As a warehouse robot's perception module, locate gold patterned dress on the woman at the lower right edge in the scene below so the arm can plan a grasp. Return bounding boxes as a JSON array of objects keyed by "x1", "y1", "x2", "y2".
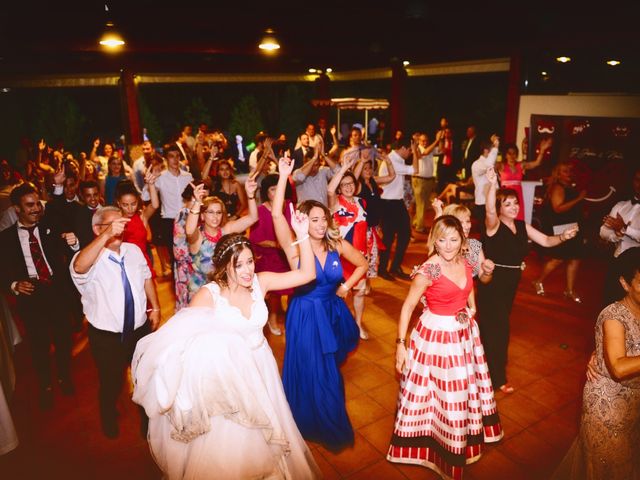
[{"x1": 553, "y1": 302, "x2": 640, "y2": 480}]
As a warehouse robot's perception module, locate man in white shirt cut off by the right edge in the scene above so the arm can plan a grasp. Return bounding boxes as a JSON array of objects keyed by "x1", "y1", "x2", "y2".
[{"x1": 600, "y1": 169, "x2": 640, "y2": 306}]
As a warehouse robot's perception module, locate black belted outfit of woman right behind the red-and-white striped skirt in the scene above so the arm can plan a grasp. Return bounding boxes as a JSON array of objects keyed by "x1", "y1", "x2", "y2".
[{"x1": 478, "y1": 220, "x2": 529, "y2": 388}]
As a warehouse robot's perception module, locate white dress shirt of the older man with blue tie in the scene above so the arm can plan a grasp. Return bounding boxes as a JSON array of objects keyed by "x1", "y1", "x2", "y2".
[{"x1": 69, "y1": 242, "x2": 151, "y2": 333}]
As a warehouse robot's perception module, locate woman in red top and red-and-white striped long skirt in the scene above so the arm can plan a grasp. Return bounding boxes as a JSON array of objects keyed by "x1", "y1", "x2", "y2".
[{"x1": 387, "y1": 215, "x2": 503, "y2": 478}]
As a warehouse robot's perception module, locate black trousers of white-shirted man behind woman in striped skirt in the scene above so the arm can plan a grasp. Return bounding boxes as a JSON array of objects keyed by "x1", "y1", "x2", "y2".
[{"x1": 379, "y1": 200, "x2": 411, "y2": 272}]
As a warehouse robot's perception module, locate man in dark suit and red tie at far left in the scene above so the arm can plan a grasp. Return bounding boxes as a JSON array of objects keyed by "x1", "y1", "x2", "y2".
[{"x1": 0, "y1": 179, "x2": 79, "y2": 409}]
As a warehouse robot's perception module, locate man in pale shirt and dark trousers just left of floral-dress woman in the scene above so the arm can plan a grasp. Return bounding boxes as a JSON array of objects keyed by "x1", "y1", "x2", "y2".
[{"x1": 142, "y1": 143, "x2": 193, "y2": 276}]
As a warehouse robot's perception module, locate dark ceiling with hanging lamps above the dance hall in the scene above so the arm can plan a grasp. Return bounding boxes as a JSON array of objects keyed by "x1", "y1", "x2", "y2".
[{"x1": 0, "y1": 0, "x2": 640, "y2": 82}]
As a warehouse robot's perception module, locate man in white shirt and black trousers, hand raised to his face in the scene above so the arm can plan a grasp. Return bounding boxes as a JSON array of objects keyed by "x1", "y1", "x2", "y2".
[{"x1": 378, "y1": 140, "x2": 418, "y2": 280}]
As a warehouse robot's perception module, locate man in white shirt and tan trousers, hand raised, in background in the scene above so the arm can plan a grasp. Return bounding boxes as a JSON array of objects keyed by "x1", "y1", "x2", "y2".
[{"x1": 411, "y1": 132, "x2": 442, "y2": 233}]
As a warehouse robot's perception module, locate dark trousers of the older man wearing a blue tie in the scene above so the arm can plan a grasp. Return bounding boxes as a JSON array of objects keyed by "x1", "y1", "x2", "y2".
[{"x1": 89, "y1": 322, "x2": 151, "y2": 423}]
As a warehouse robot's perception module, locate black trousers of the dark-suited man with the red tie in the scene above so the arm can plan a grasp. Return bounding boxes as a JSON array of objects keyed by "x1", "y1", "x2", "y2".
[{"x1": 17, "y1": 279, "x2": 71, "y2": 389}]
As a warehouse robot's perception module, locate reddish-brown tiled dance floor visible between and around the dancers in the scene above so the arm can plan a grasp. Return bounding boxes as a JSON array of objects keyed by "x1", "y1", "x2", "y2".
[{"x1": 0, "y1": 231, "x2": 604, "y2": 480}]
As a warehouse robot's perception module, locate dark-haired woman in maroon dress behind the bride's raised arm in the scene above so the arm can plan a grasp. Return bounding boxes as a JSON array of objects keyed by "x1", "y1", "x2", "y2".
[{"x1": 249, "y1": 174, "x2": 293, "y2": 335}]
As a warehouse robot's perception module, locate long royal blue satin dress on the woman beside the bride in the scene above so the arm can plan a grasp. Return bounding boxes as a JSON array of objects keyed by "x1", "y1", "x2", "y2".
[{"x1": 282, "y1": 251, "x2": 359, "y2": 451}]
